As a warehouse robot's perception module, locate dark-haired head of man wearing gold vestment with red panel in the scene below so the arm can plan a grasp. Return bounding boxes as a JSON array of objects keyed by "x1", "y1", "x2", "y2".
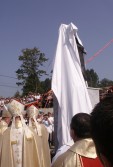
[{"x1": 70, "y1": 113, "x2": 91, "y2": 138}]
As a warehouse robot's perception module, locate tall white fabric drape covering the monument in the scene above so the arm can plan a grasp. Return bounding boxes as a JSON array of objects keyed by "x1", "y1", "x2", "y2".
[{"x1": 52, "y1": 23, "x2": 92, "y2": 147}]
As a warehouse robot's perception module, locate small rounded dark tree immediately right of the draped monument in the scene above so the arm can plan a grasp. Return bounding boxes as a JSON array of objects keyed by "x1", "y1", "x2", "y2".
[{"x1": 86, "y1": 69, "x2": 99, "y2": 87}]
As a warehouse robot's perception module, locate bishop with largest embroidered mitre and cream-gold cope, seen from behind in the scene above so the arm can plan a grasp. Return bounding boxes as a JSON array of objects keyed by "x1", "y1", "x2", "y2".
[{"x1": 0, "y1": 99, "x2": 42, "y2": 167}]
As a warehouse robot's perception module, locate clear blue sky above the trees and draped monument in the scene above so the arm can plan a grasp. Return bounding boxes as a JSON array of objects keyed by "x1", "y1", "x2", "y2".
[{"x1": 0, "y1": 0, "x2": 113, "y2": 97}]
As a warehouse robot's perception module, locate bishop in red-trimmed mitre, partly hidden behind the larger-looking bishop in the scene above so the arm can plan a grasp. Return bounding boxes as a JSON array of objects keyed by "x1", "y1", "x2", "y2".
[{"x1": 27, "y1": 104, "x2": 51, "y2": 167}]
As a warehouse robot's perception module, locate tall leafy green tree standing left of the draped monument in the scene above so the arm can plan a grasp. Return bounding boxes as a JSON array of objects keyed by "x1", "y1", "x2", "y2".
[{"x1": 16, "y1": 47, "x2": 48, "y2": 95}]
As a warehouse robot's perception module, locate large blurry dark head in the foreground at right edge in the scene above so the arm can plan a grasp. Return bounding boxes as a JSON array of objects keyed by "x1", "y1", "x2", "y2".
[{"x1": 91, "y1": 94, "x2": 113, "y2": 165}]
